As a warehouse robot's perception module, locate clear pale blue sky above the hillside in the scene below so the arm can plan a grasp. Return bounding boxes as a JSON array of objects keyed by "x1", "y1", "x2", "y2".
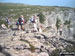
[{"x1": 0, "y1": 0, "x2": 75, "y2": 8}]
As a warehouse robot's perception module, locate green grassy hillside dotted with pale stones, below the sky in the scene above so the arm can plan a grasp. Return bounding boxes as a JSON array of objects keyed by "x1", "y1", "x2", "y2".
[{"x1": 0, "y1": 3, "x2": 74, "y2": 19}]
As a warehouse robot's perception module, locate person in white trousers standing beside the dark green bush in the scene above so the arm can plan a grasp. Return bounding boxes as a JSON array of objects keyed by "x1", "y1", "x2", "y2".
[{"x1": 30, "y1": 15, "x2": 42, "y2": 32}]
